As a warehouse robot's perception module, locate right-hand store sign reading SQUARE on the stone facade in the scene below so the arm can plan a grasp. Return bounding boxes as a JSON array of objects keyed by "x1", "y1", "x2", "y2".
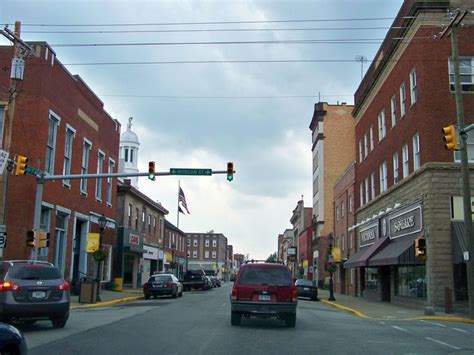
[{"x1": 389, "y1": 203, "x2": 423, "y2": 239}]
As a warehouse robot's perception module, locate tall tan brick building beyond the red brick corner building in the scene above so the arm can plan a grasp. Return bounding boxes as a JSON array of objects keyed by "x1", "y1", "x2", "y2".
[{"x1": 309, "y1": 102, "x2": 355, "y2": 285}]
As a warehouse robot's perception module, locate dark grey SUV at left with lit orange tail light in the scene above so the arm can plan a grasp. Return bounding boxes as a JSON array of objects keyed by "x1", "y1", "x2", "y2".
[{"x1": 0, "y1": 260, "x2": 70, "y2": 328}]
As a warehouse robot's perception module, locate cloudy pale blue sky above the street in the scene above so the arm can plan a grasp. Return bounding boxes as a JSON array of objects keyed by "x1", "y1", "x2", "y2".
[{"x1": 0, "y1": 0, "x2": 403, "y2": 259}]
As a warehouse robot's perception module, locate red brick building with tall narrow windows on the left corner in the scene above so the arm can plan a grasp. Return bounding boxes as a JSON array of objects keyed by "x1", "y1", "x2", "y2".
[{"x1": 0, "y1": 42, "x2": 120, "y2": 290}]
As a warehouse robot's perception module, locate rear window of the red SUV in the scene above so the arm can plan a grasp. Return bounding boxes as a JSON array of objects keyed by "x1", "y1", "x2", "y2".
[{"x1": 239, "y1": 266, "x2": 292, "y2": 286}]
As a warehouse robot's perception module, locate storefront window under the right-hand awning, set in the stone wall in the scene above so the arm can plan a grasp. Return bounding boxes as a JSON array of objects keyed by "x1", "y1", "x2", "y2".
[{"x1": 395, "y1": 265, "x2": 426, "y2": 298}]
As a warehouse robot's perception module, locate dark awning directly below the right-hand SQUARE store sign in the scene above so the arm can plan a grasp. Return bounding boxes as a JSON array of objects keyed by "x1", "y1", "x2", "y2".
[{"x1": 368, "y1": 234, "x2": 424, "y2": 266}]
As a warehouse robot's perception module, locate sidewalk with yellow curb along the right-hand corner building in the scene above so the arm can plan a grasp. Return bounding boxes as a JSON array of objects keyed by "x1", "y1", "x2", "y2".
[{"x1": 318, "y1": 289, "x2": 474, "y2": 324}]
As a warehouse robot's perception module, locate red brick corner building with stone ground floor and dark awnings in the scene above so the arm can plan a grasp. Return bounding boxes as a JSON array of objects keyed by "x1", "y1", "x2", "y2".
[{"x1": 345, "y1": 0, "x2": 474, "y2": 310}]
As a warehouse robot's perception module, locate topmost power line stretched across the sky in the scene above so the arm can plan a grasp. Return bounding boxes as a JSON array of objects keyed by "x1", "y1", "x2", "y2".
[{"x1": 11, "y1": 17, "x2": 394, "y2": 27}]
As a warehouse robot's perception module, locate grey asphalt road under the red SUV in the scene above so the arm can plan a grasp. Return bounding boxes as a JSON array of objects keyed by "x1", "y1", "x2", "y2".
[{"x1": 22, "y1": 284, "x2": 474, "y2": 355}]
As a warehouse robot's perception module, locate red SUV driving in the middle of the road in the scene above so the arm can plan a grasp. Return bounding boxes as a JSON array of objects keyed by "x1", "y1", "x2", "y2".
[{"x1": 230, "y1": 263, "x2": 298, "y2": 328}]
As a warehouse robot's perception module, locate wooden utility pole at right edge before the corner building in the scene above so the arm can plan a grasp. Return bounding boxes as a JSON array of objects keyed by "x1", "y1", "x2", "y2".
[{"x1": 441, "y1": 10, "x2": 474, "y2": 319}]
